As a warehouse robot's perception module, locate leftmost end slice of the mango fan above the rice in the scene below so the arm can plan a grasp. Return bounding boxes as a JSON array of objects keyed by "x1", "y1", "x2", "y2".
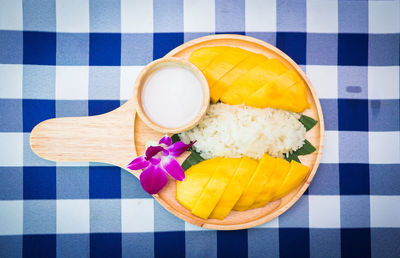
[{"x1": 189, "y1": 46, "x2": 229, "y2": 71}]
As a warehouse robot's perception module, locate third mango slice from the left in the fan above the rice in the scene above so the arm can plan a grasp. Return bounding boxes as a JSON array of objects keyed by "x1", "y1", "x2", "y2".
[{"x1": 210, "y1": 54, "x2": 268, "y2": 103}]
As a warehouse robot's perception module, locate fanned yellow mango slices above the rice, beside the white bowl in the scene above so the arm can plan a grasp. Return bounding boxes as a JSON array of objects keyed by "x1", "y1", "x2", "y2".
[{"x1": 189, "y1": 46, "x2": 309, "y2": 112}]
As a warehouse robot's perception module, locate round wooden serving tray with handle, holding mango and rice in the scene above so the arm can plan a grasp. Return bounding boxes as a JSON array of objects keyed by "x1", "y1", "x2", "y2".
[{"x1": 30, "y1": 35, "x2": 324, "y2": 230}]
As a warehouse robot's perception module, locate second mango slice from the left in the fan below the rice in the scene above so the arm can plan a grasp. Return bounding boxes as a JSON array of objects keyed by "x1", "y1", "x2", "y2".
[{"x1": 192, "y1": 158, "x2": 241, "y2": 219}]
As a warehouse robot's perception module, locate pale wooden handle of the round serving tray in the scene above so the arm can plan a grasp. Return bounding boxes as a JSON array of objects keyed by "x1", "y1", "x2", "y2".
[{"x1": 30, "y1": 100, "x2": 136, "y2": 168}]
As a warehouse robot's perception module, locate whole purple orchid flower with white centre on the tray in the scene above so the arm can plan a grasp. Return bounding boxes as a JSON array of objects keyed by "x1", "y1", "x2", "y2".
[{"x1": 127, "y1": 136, "x2": 195, "y2": 194}]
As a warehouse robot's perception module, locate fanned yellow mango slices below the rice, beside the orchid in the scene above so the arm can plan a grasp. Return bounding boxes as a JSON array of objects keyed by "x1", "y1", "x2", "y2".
[{"x1": 176, "y1": 154, "x2": 309, "y2": 219}]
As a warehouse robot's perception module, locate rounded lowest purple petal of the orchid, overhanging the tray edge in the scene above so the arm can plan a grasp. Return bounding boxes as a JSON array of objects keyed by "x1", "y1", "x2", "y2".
[{"x1": 140, "y1": 166, "x2": 168, "y2": 194}]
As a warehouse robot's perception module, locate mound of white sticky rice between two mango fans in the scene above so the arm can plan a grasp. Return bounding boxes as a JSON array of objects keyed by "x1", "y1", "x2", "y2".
[{"x1": 179, "y1": 103, "x2": 306, "y2": 159}]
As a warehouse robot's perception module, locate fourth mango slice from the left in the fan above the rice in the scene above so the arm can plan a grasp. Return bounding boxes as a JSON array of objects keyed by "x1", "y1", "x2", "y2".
[{"x1": 221, "y1": 59, "x2": 288, "y2": 105}]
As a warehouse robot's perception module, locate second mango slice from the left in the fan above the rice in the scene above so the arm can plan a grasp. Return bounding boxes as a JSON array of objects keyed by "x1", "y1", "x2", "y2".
[{"x1": 203, "y1": 47, "x2": 252, "y2": 89}]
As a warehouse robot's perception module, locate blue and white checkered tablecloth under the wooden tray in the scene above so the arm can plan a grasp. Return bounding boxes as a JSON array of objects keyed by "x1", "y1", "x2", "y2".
[{"x1": 0, "y1": 0, "x2": 400, "y2": 257}]
